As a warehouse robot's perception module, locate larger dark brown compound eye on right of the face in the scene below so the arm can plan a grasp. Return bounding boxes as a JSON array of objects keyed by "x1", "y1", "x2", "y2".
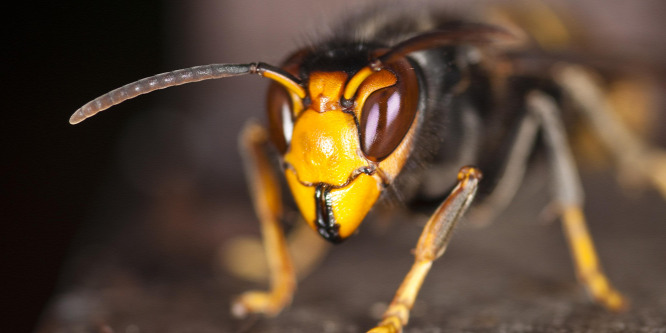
[{"x1": 360, "y1": 76, "x2": 417, "y2": 162}]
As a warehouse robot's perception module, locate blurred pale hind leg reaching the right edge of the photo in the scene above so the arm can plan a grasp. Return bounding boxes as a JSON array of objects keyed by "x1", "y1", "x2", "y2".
[{"x1": 555, "y1": 65, "x2": 666, "y2": 199}]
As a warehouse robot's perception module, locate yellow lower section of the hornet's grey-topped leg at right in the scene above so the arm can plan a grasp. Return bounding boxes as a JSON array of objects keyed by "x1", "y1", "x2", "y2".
[{"x1": 562, "y1": 206, "x2": 627, "y2": 311}]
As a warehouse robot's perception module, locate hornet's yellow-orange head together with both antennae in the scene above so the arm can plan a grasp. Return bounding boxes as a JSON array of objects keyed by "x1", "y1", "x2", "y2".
[{"x1": 70, "y1": 24, "x2": 512, "y2": 242}]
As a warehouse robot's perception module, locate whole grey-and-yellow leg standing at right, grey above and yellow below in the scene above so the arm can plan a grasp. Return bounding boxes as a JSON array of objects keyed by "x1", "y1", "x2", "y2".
[{"x1": 527, "y1": 92, "x2": 627, "y2": 311}]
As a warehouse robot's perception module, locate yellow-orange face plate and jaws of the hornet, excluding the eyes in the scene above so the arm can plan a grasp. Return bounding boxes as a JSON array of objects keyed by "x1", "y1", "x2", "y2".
[{"x1": 268, "y1": 60, "x2": 416, "y2": 242}]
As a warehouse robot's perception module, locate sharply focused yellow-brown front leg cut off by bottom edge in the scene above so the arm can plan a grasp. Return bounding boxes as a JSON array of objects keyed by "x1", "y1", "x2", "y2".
[{"x1": 369, "y1": 167, "x2": 481, "y2": 333}]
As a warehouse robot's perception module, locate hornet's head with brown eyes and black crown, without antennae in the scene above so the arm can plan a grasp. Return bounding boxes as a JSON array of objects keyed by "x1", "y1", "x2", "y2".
[{"x1": 268, "y1": 45, "x2": 420, "y2": 242}]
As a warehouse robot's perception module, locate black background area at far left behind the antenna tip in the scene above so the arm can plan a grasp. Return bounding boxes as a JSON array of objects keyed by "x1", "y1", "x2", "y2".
[{"x1": 0, "y1": 0, "x2": 165, "y2": 332}]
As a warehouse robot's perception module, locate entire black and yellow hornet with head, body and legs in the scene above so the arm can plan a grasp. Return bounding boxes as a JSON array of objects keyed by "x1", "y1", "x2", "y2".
[{"x1": 70, "y1": 3, "x2": 666, "y2": 332}]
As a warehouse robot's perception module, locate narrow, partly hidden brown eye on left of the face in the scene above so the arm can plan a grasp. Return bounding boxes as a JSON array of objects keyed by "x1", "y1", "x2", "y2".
[{"x1": 266, "y1": 83, "x2": 294, "y2": 154}]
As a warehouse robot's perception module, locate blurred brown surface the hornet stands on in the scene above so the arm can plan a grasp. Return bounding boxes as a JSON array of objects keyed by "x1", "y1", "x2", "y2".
[{"x1": 39, "y1": 170, "x2": 666, "y2": 332}]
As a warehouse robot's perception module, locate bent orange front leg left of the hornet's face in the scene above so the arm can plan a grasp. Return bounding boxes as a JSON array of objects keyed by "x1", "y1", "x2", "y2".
[{"x1": 232, "y1": 123, "x2": 296, "y2": 317}]
